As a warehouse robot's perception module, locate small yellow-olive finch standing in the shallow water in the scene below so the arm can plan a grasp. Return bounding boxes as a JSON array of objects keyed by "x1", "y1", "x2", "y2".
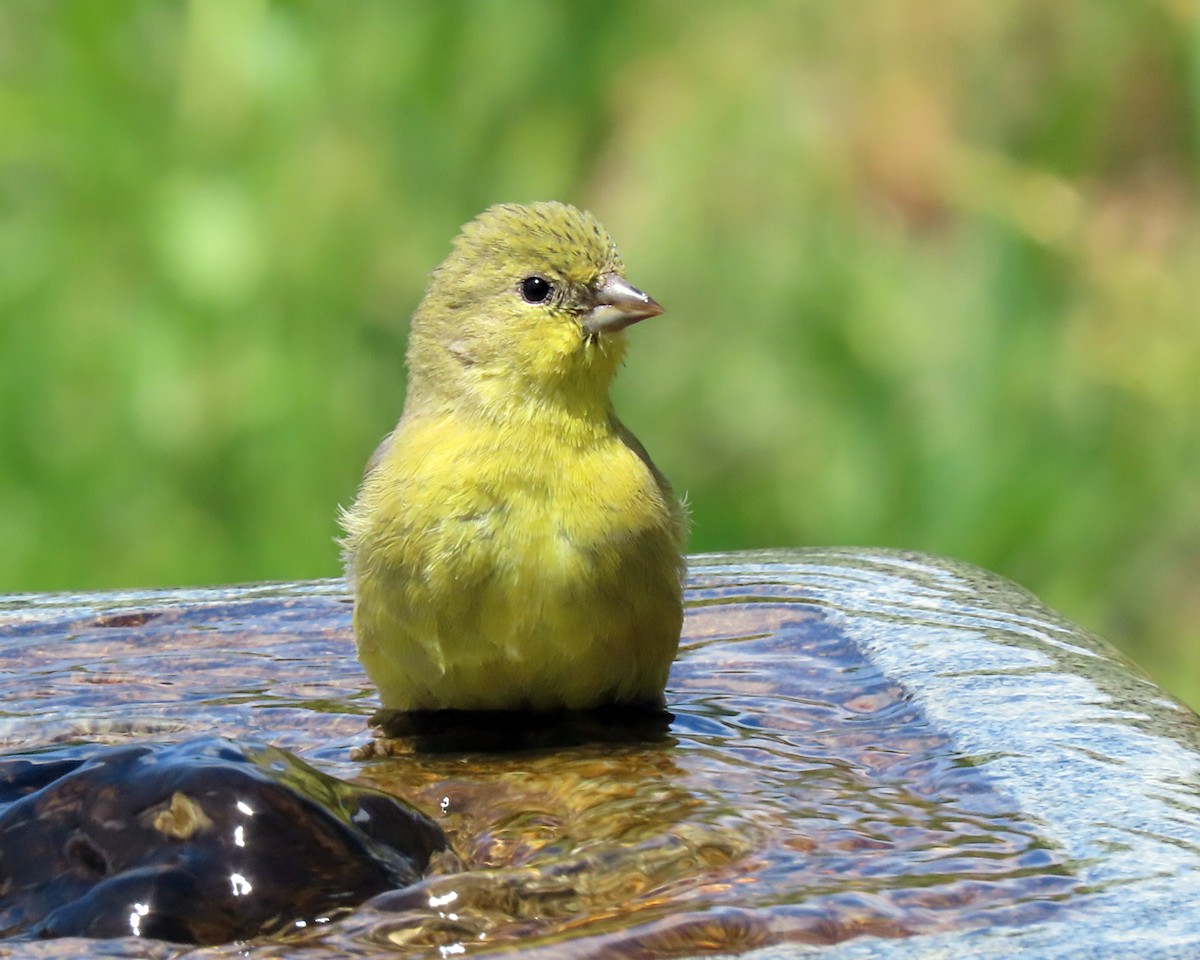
[{"x1": 341, "y1": 202, "x2": 686, "y2": 713}]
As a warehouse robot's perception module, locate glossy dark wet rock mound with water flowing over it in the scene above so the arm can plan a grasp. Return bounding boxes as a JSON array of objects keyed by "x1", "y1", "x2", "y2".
[{"x1": 0, "y1": 738, "x2": 446, "y2": 944}]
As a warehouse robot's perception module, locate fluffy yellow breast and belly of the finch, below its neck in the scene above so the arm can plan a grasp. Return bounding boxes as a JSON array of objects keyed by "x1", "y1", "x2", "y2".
[{"x1": 348, "y1": 415, "x2": 682, "y2": 709}]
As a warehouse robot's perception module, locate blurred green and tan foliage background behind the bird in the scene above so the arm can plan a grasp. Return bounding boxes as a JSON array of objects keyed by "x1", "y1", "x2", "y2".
[{"x1": 0, "y1": 0, "x2": 1200, "y2": 703}]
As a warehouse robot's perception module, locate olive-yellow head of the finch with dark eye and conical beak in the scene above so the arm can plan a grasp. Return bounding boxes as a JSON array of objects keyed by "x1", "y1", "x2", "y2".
[{"x1": 408, "y1": 202, "x2": 662, "y2": 408}]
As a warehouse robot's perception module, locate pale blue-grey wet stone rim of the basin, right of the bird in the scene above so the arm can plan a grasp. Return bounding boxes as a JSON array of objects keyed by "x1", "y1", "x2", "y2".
[{"x1": 692, "y1": 551, "x2": 1200, "y2": 960}]
